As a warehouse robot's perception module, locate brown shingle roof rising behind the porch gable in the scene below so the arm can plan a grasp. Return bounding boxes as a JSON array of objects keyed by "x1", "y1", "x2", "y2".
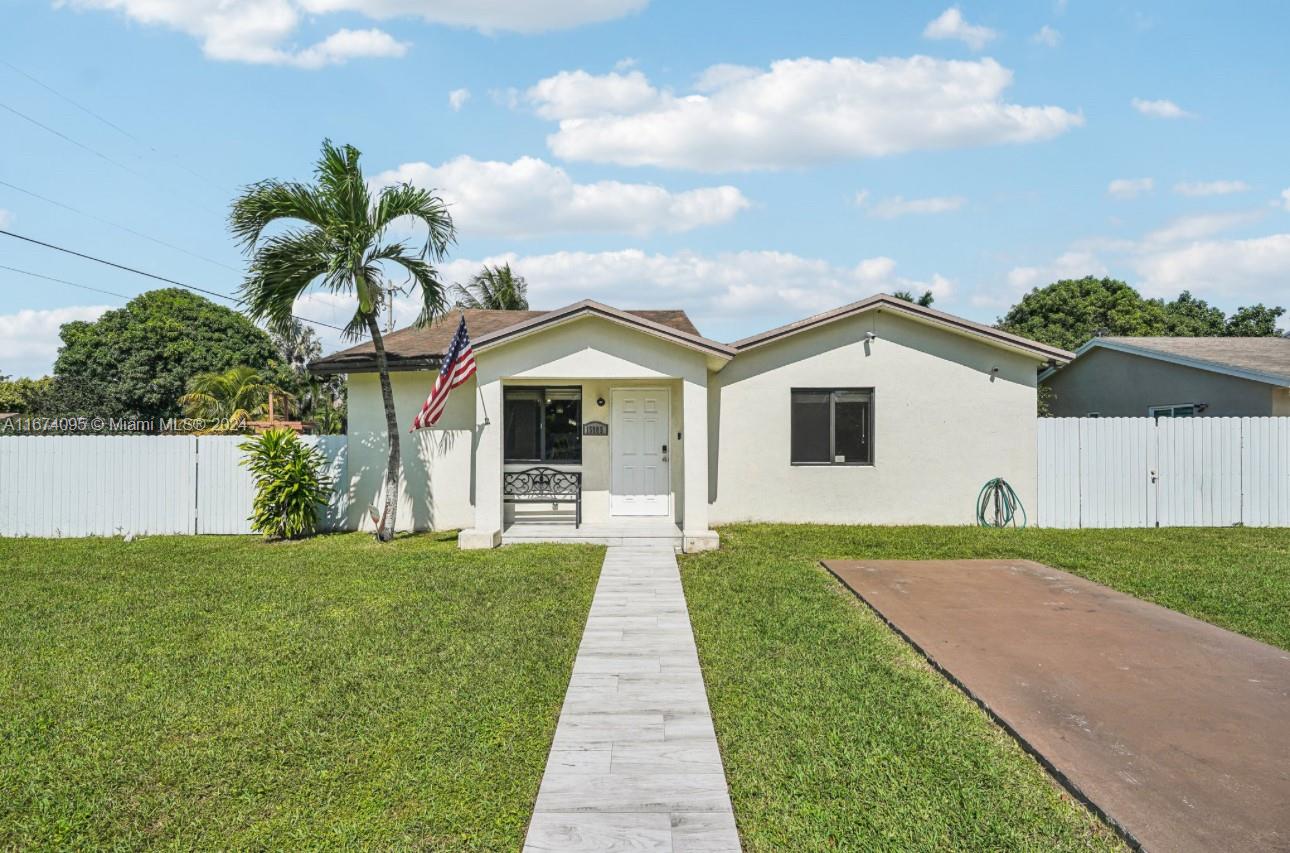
[{"x1": 310, "y1": 308, "x2": 699, "y2": 373}]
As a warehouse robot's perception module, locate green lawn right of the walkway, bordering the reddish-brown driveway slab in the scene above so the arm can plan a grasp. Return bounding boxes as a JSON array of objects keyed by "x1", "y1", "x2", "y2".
[{"x1": 681, "y1": 525, "x2": 1290, "y2": 852}]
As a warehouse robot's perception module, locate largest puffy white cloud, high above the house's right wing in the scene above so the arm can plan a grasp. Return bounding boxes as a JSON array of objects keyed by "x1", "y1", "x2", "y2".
[{"x1": 528, "y1": 57, "x2": 1084, "y2": 172}]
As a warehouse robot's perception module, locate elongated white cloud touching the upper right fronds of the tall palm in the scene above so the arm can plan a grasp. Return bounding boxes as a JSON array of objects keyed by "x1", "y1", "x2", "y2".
[{"x1": 375, "y1": 156, "x2": 749, "y2": 237}]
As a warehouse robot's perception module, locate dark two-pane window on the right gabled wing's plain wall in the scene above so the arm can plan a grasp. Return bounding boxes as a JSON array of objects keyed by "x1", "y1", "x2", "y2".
[{"x1": 791, "y1": 388, "x2": 873, "y2": 465}]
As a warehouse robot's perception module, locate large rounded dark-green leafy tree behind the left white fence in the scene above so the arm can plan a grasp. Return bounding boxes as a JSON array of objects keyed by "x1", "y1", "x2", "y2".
[{"x1": 49, "y1": 288, "x2": 281, "y2": 418}]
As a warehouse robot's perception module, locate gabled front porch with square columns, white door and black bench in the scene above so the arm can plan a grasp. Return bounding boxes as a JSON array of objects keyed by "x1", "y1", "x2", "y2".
[{"x1": 458, "y1": 308, "x2": 729, "y2": 551}]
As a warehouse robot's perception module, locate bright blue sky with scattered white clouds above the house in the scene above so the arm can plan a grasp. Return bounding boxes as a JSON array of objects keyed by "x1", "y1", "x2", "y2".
[{"x1": 0, "y1": 0, "x2": 1290, "y2": 376}]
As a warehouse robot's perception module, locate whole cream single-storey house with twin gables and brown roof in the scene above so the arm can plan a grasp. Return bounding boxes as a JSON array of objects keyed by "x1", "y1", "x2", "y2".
[{"x1": 311, "y1": 296, "x2": 1072, "y2": 550}]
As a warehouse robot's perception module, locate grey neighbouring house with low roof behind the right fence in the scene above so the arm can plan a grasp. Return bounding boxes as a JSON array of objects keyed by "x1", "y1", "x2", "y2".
[{"x1": 1040, "y1": 338, "x2": 1290, "y2": 418}]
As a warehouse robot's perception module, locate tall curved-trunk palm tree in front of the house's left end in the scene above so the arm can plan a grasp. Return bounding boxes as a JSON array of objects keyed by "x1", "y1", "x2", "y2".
[{"x1": 228, "y1": 139, "x2": 455, "y2": 542}]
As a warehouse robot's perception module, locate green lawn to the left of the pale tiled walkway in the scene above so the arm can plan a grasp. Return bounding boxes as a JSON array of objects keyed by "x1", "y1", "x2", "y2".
[{"x1": 0, "y1": 534, "x2": 602, "y2": 850}]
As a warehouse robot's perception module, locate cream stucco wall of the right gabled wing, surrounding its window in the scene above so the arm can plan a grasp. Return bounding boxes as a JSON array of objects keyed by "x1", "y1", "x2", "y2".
[{"x1": 708, "y1": 311, "x2": 1038, "y2": 524}]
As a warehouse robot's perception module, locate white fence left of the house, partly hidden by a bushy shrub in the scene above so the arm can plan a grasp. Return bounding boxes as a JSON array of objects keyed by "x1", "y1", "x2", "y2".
[{"x1": 0, "y1": 435, "x2": 348, "y2": 537}]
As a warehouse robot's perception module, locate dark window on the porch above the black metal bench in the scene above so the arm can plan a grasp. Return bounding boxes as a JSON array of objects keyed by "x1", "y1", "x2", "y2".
[{"x1": 502, "y1": 388, "x2": 582, "y2": 463}]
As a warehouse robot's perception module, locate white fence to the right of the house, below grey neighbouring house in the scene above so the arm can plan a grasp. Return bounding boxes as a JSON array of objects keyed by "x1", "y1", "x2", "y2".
[{"x1": 1037, "y1": 418, "x2": 1290, "y2": 528}]
